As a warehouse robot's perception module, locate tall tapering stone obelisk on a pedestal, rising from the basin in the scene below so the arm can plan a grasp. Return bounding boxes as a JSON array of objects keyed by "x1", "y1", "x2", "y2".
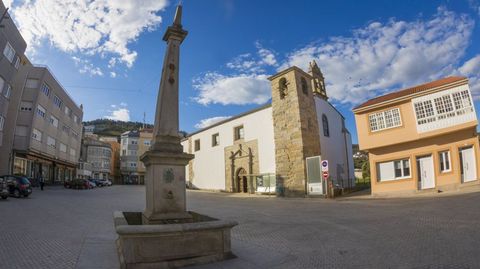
[{"x1": 141, "y1": 5, "x2": 194, "y2": 224}]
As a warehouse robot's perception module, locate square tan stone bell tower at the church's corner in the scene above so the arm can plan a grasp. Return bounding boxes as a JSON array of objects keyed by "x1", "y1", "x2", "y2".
[{"x1": 269, "y1": 67, "x2": 320, "y2": 197}]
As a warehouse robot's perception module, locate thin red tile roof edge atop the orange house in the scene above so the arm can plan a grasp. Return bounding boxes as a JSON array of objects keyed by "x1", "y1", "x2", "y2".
[{"x1": 353, "y1": 77, "x2": 466, "y2": 110}]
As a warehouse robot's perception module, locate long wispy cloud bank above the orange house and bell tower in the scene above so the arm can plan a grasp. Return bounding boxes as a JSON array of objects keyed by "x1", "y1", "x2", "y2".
[{"x1": 279, "y1": 7, "x2": 474, "y2": 104}]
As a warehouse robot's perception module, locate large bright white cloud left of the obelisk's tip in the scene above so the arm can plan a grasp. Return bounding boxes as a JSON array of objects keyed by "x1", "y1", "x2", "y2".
[{"x1": 13, "y1": 0, "x2": 167, "y2": 67}]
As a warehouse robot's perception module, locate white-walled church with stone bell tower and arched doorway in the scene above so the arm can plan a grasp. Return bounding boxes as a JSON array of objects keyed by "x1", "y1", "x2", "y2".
[{"x1": 182, "y1": 62, "x2": 355, "y2": 197}]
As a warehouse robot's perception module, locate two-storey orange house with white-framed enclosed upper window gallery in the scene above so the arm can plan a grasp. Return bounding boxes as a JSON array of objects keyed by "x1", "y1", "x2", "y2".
[{"x1": 353, "y1": 77, "x2": 480, "y2": 195}]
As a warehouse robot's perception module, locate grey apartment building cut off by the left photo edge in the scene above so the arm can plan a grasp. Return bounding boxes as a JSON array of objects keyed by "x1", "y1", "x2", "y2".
[{"x1": 0, "y1": 1, "x2": 27, "y2": 175}]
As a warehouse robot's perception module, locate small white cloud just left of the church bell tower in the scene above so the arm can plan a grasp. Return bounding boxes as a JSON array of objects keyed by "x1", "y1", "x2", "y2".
[{"x1": 193, "y1": 72, "x2": 271, "y2": 105}]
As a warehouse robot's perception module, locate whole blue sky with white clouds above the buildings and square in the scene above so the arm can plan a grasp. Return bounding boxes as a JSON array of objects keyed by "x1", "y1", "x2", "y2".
[{"x1": 4, "y1": 0, "x2": 480, "y2": 142}]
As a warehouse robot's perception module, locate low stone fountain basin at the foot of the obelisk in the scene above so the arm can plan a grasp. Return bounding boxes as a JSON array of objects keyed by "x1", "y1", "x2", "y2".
[{"x1": 114, "y1": 211, "x2": 238, "y2": 269}]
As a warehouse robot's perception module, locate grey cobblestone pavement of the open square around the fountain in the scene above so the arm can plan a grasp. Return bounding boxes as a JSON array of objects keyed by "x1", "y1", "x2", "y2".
[{"x1": 0, "y1": 186, "x2": 480, "y2": 269}]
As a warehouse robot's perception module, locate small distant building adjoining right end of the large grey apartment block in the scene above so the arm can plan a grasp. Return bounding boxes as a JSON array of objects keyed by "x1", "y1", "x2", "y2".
[{"x1": 80, "y1": 137, "x2": 113, "y2": 179}]
